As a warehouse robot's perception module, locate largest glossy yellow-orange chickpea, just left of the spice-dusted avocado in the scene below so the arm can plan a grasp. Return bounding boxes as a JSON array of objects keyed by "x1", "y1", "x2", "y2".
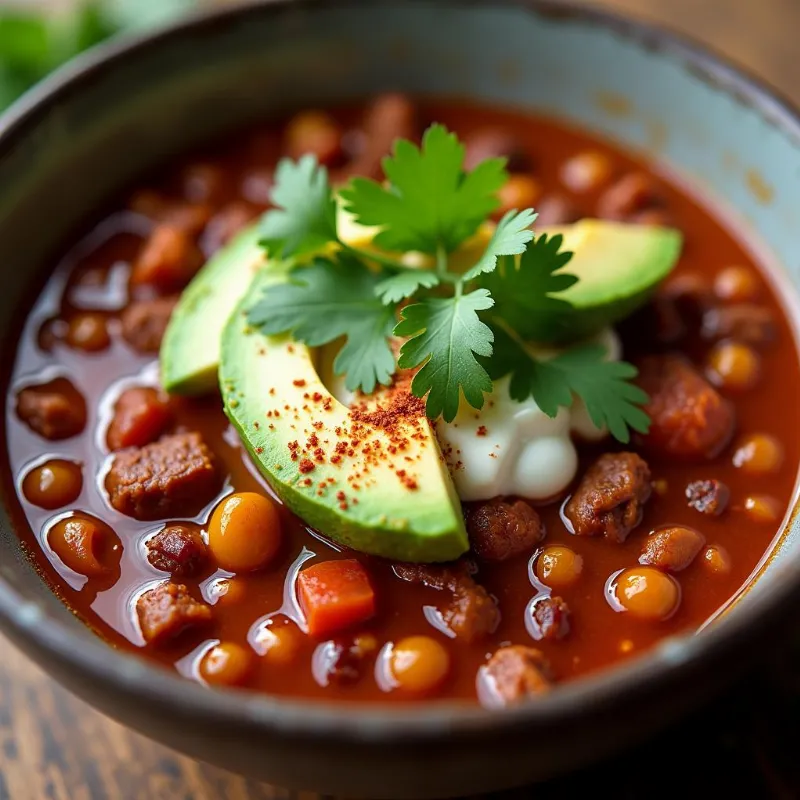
[{"x1": 208, "y1": 492, "x2": 281, "y2": 572}]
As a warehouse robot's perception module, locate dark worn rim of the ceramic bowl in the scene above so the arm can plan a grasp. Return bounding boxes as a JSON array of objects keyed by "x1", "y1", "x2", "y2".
[{"x1": 0, "y1": 0, "x2": 800, "y2": 745}]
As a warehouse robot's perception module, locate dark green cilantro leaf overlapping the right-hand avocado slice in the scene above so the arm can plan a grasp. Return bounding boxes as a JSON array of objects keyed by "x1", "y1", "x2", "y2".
[{"x1": 481, "y1": 233, "x2": 578, "y2": 341}]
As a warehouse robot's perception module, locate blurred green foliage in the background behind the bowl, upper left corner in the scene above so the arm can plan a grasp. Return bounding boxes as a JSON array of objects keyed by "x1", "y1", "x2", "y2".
[{"x1": 0, "y1": 0, "x2": 197, "y2": 110}]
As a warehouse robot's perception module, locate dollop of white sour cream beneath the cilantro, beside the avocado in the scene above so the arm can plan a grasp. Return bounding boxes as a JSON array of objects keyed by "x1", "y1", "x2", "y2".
[{"x1": 326, "y1": 328, "x2": 621, "y2": 501}]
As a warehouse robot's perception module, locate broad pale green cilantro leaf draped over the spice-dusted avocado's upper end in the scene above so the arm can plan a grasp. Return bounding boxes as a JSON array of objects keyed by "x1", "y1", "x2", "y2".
[{"x1": 248, "y1": 255, "x2": 395, "y2": 394}]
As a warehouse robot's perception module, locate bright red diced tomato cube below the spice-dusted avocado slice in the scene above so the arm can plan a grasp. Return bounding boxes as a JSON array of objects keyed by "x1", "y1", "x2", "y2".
[{"x1": 297, "y1": 558, "x2": 375, "y2": 636}]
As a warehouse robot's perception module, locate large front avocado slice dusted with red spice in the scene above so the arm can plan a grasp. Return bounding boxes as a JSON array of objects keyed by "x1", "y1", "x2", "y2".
[{"x1": 219, "y1": 265, "x2": 469, "y2": 563}]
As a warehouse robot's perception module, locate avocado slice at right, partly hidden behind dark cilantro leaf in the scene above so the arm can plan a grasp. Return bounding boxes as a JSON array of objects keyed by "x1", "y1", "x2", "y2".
[{"x1": 512, "y1": 219, "x2": 683, "y2": 344}]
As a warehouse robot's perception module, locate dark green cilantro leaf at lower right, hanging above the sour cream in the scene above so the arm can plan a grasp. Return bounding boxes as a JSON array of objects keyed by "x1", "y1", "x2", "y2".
[{"x1": 487, "y1": 326, "x2": 650, "y2": 443}]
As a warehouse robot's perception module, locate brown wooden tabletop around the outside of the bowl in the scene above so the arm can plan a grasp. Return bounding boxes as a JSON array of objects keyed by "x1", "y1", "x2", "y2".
[{"x1": 0, "y1": 0, "x2": 800, "y2": 800}]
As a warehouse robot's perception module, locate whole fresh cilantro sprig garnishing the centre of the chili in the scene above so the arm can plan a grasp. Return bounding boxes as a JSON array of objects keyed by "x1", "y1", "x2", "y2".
[{"x1": 249, "y1": 125, "x2": 649, "y2": 442}]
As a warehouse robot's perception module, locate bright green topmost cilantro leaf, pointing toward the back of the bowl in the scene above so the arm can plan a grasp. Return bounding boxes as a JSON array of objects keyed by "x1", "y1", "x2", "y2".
[{"x1": 342, "y1": 125, "x2": 508, "y2": 254}]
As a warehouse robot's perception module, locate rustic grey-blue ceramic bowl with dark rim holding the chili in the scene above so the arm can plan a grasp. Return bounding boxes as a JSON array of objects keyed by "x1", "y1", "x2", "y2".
[{"x1": 0, "y1": 0, "x2": 800, "y2": 797}]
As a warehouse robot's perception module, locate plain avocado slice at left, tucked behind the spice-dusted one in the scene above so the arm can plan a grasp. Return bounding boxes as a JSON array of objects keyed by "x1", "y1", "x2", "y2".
[{"x1": 160, "y1": 225, "x2": 266, "y2": 395}]
